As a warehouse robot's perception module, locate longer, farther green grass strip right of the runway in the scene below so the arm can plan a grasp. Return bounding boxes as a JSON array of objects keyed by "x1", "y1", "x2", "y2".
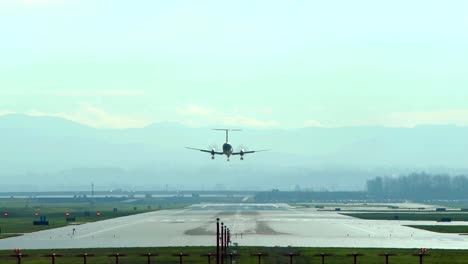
[{"x1": 343, "y1": 212, "x2": 468, "y2": 221}]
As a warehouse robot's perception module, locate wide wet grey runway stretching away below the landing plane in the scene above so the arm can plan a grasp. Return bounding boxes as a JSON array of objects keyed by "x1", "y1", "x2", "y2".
[{"x1": 0, "y1": 204, "x2": 468, "y2": 249}]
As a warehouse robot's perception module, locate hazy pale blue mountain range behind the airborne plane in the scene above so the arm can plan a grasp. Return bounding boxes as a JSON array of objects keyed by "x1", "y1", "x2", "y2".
[{"x1": 0, "y1": 115, "x2": 468, "y2": 190}]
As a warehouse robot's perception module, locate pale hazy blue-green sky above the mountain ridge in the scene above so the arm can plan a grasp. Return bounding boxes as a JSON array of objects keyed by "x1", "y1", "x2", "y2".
[{"x1": 0, "y1": 0, "x2": 468, "y2": 128}]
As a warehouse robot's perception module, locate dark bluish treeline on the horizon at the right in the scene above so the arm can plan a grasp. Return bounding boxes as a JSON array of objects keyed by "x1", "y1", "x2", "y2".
[{"x1": 367, "y1": 173, "x2": 468, "y2": 200}]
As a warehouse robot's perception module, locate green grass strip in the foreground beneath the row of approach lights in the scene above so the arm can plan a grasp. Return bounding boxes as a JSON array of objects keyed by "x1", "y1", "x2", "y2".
[{"x1": 0, "y1": 247, "x2": 468, "y2": 264}]
